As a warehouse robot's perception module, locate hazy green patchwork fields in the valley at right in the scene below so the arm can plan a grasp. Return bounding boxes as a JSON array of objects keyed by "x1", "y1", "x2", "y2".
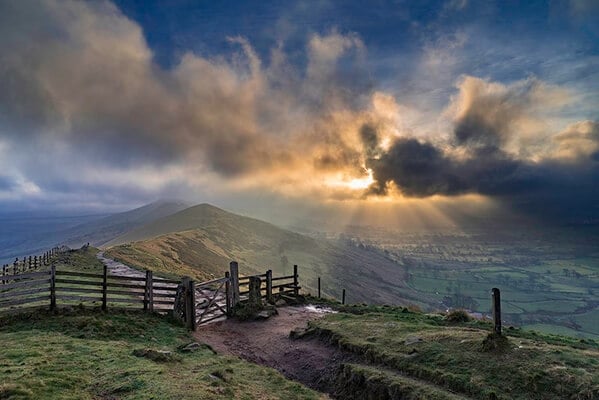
[{"x1": 336, "y1": 229, "x2": 599, "y2": 339}]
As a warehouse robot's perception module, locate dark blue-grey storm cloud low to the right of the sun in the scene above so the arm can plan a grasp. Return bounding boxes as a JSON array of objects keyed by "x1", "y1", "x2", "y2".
[{"x1": 364, "y1": 117, "x2": 599, "y2": 221}]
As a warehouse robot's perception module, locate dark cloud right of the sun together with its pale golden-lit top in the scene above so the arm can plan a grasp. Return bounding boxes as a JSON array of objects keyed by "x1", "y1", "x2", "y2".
[{"x1": 362, "y1": 77, "x2": 599, "y2": 220}]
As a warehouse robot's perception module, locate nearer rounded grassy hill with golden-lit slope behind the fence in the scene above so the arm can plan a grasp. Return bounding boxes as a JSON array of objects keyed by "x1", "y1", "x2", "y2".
[{"x1": 106, "y1": 204, "x2": 418, "y2": 303}]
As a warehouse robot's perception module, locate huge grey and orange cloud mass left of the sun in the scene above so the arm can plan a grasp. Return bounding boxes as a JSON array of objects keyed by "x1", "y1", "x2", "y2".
[{"x1": 0, "y1": 0, "x2": 372, "y2": 198}]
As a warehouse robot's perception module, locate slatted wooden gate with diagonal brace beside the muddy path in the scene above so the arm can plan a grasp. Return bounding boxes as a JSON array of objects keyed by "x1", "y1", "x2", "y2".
[{"x1": 195, "y1": 274, "x2": 230, "y2": 326}]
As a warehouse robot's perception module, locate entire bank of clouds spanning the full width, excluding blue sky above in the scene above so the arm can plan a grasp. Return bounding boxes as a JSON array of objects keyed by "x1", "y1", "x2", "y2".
[{"x1": 0, "y1": 0, "x2": 599, "y2": 222}]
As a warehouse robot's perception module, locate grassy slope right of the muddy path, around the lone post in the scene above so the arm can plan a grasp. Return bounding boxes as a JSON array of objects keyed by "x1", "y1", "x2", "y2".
[{"x1": 312, "y1": 307, "x2": 599, "y2": 399}]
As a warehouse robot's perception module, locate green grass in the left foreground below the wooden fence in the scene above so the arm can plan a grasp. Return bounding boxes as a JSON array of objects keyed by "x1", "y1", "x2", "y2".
[{"x1": 0, "y1": 310, "x2": 322, "y2": 400}]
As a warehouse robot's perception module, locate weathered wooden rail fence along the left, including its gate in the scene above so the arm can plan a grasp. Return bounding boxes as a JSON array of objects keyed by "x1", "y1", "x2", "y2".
[{"x1": 0, "y1": 256, "x2": 300, "y2": 330}]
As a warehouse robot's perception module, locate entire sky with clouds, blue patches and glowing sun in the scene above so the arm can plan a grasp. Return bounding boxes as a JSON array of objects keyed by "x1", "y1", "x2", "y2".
[{"x1": 0, "y1": 0, "x2": 599, "y2": 225}]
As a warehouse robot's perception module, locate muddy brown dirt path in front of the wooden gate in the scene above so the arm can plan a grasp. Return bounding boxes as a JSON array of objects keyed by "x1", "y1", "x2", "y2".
[{"x1": 195, "y1": 306, "x2": 352, "y2": 392}]
